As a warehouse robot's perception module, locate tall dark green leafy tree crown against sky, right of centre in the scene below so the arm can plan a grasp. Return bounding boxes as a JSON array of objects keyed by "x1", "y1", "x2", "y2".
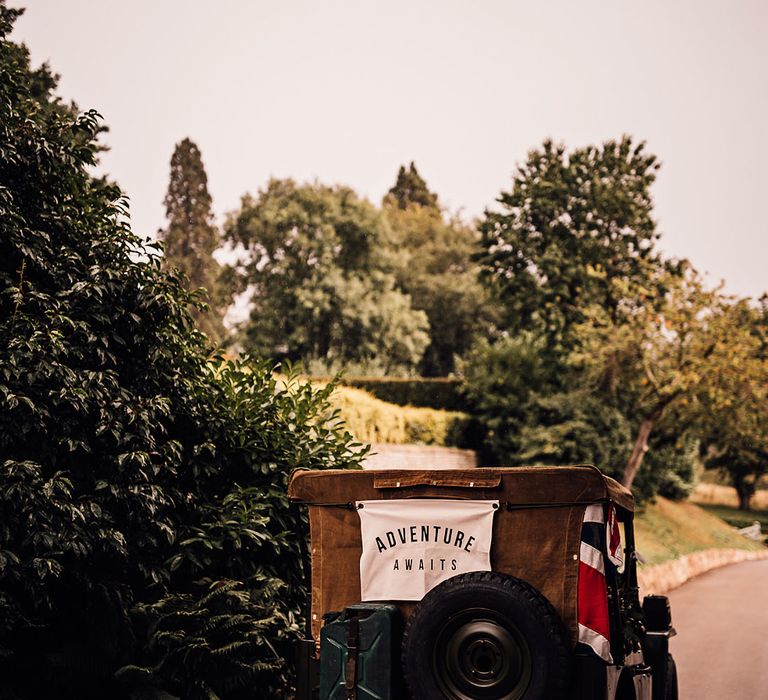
[{"x1": 478, "y1": 136, "x2": 660, "y2": 353}]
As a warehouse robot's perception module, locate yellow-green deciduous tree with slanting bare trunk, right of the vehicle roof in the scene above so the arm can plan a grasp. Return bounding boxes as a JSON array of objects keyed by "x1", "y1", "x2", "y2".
[{"x1": 572, "y1": 268, "x2": 749, "y2": 486}]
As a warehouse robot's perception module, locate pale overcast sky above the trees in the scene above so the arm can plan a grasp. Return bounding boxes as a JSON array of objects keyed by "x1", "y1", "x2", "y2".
[{"x1": 9, "y1": 0, "x2": 768, "y2": 296}]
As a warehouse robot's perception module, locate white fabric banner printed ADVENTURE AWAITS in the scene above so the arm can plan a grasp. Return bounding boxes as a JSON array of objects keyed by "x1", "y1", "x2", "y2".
[{"x1": 356, "y1": 498, "x2": 499, "y2": 600}]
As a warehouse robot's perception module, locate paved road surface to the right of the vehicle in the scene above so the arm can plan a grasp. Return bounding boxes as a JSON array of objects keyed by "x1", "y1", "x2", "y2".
[{"x1": 669, "y1": 559, "x2": 768, "y2": 700}]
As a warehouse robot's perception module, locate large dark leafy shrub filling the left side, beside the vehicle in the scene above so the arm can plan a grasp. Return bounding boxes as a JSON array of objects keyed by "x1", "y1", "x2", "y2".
[{"x1": 0, "y1": 4, "x2": 358, "y2": 698}]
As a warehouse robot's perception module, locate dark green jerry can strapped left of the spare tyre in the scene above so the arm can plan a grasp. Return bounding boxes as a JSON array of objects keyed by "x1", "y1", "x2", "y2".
[{"x1": 320, "y1": 603, "x2": 403, "y2": 700}]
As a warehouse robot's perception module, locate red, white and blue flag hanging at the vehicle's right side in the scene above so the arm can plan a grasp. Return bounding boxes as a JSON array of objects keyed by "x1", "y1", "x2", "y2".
[{"x1": 578, "y1": 504, "x2": 623, "y2": 663}]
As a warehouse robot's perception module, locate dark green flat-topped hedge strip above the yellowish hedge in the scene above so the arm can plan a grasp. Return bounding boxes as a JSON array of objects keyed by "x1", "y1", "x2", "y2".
[{"x1": 316, "y1": 377, "x2": 467, "y2": 412}]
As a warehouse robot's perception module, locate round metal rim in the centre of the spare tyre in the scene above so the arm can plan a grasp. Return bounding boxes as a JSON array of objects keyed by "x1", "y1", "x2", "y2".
[{"x1": 433, "y1": 608, "x2": 532, "y2": 700}]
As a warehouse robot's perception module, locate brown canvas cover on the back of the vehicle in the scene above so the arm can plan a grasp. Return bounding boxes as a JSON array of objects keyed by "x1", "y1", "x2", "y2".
[{"x1": 288, "y1": 466, "x2": 634, "y2": 643}]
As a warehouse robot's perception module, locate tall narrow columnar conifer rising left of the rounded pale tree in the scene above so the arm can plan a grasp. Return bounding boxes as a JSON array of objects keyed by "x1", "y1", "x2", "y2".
[{"x1": 159, "y1": 138, "x2": 225, "y2": 342}]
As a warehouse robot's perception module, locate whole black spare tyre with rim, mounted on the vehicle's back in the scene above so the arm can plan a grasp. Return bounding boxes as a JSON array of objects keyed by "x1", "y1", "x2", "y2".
[{"x1": 402, "y1": 571, "x2": 572, "y2": 700}]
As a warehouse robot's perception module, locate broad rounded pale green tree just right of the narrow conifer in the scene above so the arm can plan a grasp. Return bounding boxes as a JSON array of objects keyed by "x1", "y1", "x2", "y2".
[{"x1": 225, "y1": 180, "x2": 429, "y2": 374}]
